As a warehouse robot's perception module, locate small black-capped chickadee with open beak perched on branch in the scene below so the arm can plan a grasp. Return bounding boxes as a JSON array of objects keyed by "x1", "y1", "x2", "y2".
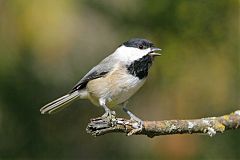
[{"x1": 40, "y1": 38, "x2": 161, "y2": 127}]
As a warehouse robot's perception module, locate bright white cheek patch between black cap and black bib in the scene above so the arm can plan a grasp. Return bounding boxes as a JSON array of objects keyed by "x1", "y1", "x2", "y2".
[{"x1": 114, "y1": 46, "x2": 150, "y2": 62}]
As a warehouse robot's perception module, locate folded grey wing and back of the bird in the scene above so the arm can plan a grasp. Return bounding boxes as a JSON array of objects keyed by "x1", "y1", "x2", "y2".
[{"x1": 70, "y1": 55, "x2": 117, "y2": 93}]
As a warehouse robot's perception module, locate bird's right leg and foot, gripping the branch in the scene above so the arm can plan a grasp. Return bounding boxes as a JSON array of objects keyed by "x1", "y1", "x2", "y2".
[{"x1": 123, "y1": 102, "x2": 143, "y2": 136}]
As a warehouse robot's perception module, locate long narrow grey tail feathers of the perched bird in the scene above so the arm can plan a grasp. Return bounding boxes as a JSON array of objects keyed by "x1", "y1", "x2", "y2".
[{"x1": 40, "y1": 91, "x2": 79, "y2": 114}]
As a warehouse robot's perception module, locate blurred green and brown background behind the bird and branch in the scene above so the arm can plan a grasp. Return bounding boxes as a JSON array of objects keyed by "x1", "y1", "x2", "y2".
[{"x1": 0, "y1": 0, "x2": 240, "y2": 159}]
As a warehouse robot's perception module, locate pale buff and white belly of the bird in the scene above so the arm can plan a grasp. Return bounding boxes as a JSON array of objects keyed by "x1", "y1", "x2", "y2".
[{"x1": 87, "y1": 67, "x2": 145, "y2": 107}]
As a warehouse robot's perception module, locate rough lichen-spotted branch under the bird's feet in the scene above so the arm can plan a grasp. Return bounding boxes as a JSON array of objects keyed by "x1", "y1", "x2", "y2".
[{"x1": 86, "y1": 110, "x2": 240, "y2": 138}]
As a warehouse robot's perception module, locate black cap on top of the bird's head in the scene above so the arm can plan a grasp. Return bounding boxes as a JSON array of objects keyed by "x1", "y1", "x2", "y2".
[{"x1": 123, "y1": 38, "x2": 154, "y2": 49}]
